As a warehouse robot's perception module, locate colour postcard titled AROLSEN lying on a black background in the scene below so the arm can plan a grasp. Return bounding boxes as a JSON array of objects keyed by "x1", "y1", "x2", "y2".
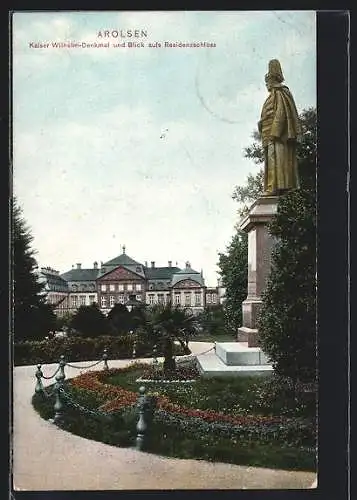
[{"x1": 11, "y1": 11, "x2": 317, "y2": 491}]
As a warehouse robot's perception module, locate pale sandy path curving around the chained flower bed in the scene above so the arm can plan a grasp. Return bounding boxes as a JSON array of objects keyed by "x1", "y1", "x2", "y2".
[{"x1": 13, "y1": 342, "x2": 316, "y2": 491}]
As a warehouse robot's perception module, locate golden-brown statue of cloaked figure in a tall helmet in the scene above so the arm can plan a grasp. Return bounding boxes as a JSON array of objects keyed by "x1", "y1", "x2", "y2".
[{"x1": 258, "y1": 59, "x2": 301, "y2": 196}]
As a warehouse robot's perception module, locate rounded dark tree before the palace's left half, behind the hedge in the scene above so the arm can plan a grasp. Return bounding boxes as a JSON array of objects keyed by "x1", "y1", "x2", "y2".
[{"x1": 69, "y1": 304, "x2": 109, "y2": 337}]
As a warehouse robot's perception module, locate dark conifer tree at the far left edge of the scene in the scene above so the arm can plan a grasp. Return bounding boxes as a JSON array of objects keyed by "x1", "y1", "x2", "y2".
[{"x1": 12, "y1": 198, "x2": 49, "y2": 341}]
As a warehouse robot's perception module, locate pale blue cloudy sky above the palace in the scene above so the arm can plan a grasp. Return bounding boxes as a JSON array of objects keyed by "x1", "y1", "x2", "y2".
[{"x1": 12, "y1": 11, "x2": 316, "y2": 286}]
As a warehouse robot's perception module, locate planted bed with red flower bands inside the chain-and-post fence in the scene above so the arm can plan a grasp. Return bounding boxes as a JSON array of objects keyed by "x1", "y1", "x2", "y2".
[{"x1": 33, "y1": 364, "x2": 316, "y2": 471}]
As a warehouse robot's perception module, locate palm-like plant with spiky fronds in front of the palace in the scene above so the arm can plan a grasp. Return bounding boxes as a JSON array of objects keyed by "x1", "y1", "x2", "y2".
[{"x1": 146, "y1": 304, "x2": 198, "y2": 372}]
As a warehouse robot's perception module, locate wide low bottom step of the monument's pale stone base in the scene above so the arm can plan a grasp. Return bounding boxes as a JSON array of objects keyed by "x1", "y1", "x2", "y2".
[{"x1": 196, "y1": 352, "x2": 273, "y2": 377}]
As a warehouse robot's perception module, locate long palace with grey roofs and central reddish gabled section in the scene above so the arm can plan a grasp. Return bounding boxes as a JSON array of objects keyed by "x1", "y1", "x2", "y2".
[{"x1": 44, "y1": 247, "x2": 221, "y2": 315}]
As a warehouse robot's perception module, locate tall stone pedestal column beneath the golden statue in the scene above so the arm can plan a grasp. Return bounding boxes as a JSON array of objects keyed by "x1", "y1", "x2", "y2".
[{"x1": 237, "y1": 196, "x2": 278, "y2": 347}]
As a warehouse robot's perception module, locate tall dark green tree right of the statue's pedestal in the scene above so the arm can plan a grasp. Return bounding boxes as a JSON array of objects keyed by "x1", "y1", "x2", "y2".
[{"x1": 258, "y1": 109, "x2": 316, "y2": 382}]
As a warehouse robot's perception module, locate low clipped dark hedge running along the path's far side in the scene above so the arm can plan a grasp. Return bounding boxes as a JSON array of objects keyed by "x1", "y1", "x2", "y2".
[{"x1": 13, "y1": 335, "x2": 183, "y2": 366}]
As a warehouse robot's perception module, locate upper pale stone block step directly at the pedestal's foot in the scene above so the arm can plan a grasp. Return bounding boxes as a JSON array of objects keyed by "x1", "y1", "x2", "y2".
[{"x1": 216, "y1": 342, "x2": 269, "y2": 366}]
